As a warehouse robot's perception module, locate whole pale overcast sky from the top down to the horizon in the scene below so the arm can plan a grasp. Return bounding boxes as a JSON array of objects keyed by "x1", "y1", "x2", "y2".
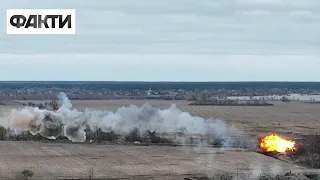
[{"x1": 0, "y1": 0, "x2": 320, "y2": 81}]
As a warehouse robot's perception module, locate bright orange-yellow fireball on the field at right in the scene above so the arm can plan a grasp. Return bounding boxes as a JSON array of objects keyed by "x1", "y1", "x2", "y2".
[{"x1": 259, "y1": 134, "x2": 295, "y2": 153}]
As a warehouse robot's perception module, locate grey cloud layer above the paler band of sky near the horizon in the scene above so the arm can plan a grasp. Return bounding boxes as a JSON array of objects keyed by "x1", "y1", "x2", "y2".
[{"x1": 0, "y1": 0, "x2": 320, "y2": 55}]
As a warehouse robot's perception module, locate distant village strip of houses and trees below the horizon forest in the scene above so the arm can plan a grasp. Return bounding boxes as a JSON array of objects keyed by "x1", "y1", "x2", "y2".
[{"x1": 0, "y1": 87, "x2": 320, "y2": 101}]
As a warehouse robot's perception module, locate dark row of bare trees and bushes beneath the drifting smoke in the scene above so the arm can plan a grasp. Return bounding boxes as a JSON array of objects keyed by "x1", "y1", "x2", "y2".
[{"x1": 0, "y1": 126, "x2": 247, "y2": 148}]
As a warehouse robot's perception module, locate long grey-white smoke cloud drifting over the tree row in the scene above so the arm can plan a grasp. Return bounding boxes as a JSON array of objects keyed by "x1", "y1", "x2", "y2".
[{"x1": 9, "y1": 93, "x2": 242, "y2": 142}]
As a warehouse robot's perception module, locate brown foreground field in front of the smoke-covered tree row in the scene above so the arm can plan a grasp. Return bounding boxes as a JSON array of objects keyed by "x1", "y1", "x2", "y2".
[{"x1": 0, "y1": 141, "x2": 316, "y2": 180}]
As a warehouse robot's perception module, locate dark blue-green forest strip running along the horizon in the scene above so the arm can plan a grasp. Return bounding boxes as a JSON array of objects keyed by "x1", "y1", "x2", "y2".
[{"x1": 0, "y1": 81, "x2": 320, "y2": 90}]
